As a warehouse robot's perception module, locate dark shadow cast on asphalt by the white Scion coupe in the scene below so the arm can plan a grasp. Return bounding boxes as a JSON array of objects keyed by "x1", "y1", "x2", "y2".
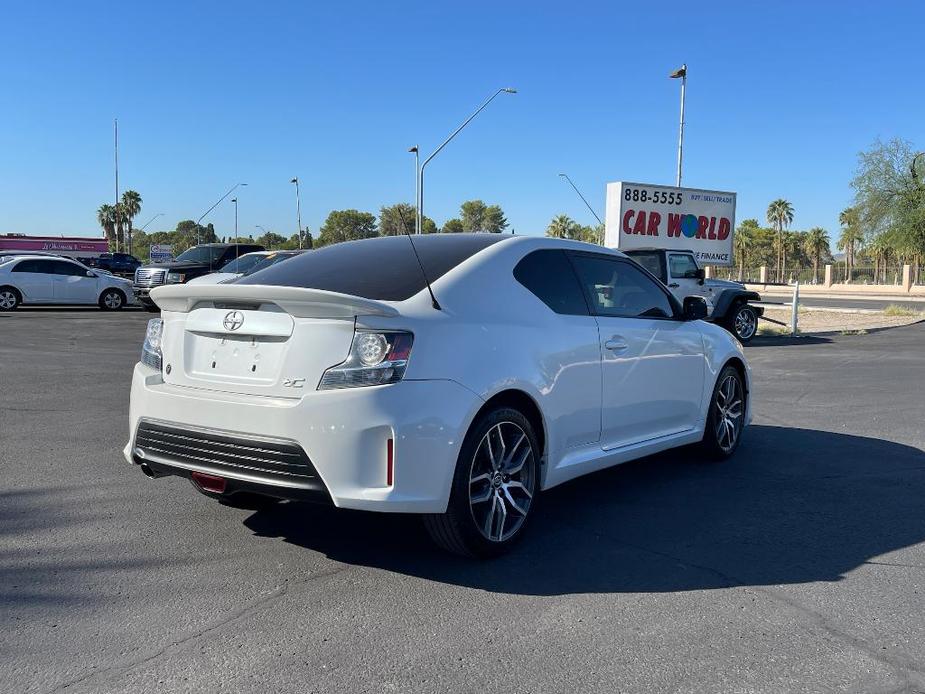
[{"x1": 245, "y1": 426, "x2": 925, "y2": 595}]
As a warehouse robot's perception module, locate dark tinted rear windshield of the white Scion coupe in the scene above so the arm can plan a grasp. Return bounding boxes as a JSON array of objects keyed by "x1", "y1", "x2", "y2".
[{"x1": 236, "y1": 234, "x2": 510, "y2": 301}]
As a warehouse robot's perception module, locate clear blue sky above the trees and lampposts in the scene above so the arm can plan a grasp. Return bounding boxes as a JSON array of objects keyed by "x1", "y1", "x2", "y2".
[{"x1": 0, "y1": 0, "x2": 925, "y2": 241}]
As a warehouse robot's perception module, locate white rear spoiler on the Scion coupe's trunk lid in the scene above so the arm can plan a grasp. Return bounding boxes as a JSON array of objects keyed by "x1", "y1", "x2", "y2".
[{"x1": 151, "y1": 284, "x2": 399, "y2": 318}]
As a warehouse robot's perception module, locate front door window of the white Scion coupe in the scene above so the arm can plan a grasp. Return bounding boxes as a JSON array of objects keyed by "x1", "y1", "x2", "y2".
[{"x1": 572, "y1": 254, "x2": 674, "y2": 318}]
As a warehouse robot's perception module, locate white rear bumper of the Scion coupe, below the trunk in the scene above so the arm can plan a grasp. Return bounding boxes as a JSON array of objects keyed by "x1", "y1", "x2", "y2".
[{"x1": 124, "y1": 364, "x2": 482, "y2": 513}]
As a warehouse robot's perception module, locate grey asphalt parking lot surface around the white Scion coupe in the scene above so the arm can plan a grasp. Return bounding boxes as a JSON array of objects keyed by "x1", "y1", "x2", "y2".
[{"x1": 0, "y1": 310, "x2": 925, "y2": 692}]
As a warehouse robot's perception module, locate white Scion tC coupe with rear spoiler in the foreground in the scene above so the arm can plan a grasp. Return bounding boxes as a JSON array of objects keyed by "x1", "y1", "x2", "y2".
[{"x1": 125, "y1": 234, "x2": 750, "y2": 556}]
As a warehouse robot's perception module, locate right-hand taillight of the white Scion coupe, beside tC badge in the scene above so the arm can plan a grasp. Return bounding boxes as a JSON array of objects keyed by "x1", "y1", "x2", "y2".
[{"x1": 318, "y1": 330, "x2": 414, "y2": 390}]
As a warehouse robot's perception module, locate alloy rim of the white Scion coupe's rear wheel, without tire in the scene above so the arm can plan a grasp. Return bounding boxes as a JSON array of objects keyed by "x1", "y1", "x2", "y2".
[{"x1": 469, "y1": 422, "x2": 536, "y2": 542}]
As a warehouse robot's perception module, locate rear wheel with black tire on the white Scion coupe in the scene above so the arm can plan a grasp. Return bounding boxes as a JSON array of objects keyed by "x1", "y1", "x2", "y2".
[{"x1": 423, "y1": 407, "x2": 542, "y2": 559}]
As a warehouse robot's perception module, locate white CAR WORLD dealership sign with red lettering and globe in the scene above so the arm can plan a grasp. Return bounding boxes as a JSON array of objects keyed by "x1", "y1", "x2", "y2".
[{"x1": 604, "y1": 181, "x2": 736, "y2": 265}]
